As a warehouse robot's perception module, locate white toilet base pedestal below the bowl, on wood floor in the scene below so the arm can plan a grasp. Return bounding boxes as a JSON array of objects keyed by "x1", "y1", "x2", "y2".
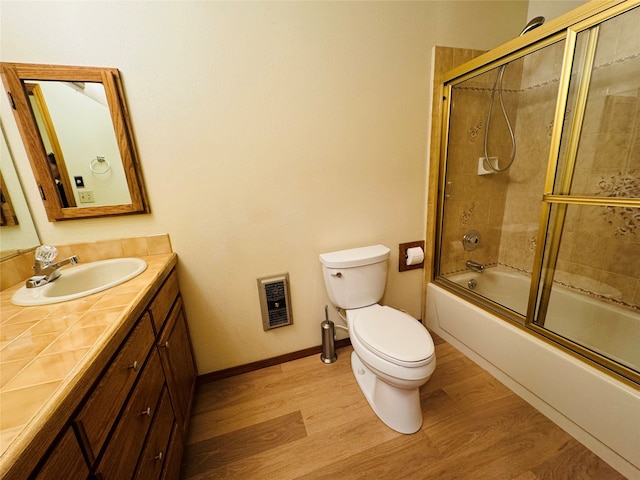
[{"x1": 351, "y1": 351, "x2": 422, "y2": 434}]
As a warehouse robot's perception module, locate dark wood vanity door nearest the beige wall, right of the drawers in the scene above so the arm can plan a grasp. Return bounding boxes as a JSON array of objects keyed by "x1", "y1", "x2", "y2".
[{"x1": 158, "y1": 297, "x2": 197, "y2": 436}]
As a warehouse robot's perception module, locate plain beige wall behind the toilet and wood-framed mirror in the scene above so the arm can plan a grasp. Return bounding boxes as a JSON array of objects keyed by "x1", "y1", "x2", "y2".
[{"x1": 0, "y1": 1, "x2": 527, "y2": 373}]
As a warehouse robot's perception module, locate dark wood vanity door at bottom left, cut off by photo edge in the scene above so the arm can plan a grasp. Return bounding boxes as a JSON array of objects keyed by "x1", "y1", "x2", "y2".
[{"x1": 33, "y1": 427, "x2": 89, "y2": 480}]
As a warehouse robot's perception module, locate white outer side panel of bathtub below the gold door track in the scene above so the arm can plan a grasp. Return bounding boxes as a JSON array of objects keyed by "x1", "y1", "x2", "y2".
[{"x1": 426, "y1": 280, "x2": 640, "y2": 479}]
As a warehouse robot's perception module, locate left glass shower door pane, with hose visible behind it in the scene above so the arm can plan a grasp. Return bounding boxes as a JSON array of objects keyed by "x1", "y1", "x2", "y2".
[{"x1": 436, "y1": 40, "x2": 565, "y2": 324}]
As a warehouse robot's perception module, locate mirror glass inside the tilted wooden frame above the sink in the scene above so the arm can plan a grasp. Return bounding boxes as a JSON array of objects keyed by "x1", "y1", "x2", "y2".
[{"x1": 25, "y1": 81, "x2": 131, "y2": 208}]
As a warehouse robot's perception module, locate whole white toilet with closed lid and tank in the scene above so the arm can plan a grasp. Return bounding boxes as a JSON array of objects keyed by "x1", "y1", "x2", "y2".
[{"x1": 320, "y1": 245, "x2": 436, "y2": 434}]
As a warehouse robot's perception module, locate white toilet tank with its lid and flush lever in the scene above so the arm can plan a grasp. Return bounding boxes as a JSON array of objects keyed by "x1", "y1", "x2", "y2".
[{"x1": 320, "y1": 245, "x2": 390, "y2": 310}]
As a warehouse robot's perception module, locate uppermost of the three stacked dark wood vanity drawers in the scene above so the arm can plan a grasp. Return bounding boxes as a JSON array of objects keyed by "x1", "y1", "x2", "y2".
[{"x1": 74, "y1": 313, "x2": 154, "y2": 462}]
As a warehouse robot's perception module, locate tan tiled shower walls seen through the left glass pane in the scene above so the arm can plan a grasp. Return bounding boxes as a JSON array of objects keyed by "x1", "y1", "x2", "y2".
[{"x1": 441, "y1": 40, "x2": 563, "y2": 274}]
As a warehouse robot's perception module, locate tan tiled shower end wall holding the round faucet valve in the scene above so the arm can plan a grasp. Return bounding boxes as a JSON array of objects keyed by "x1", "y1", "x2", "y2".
[{"x1": 440, "y1": 52, "x2": 520, "y2": 273}]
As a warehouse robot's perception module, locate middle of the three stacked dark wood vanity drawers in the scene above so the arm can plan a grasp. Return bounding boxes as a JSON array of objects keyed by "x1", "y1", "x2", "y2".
[{"x1": 96, "y1": 350, "x2": 164, "y2": 480}]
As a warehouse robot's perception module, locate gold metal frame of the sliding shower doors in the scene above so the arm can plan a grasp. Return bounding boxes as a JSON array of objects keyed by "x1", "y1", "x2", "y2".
[{"x1": 426, "y1": 0, "x2": 640, "y2": 386}]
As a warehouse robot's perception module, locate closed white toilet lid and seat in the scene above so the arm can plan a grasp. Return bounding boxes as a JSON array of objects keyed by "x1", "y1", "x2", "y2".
[{"x1": 349, "y1": 304, "x2": 434, "y2": 367}]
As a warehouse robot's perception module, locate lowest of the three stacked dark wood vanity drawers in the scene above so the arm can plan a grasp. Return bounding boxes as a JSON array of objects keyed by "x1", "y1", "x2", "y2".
[{"x1": 135, "y1": 388, "x2": 175, "y2": 480}]
